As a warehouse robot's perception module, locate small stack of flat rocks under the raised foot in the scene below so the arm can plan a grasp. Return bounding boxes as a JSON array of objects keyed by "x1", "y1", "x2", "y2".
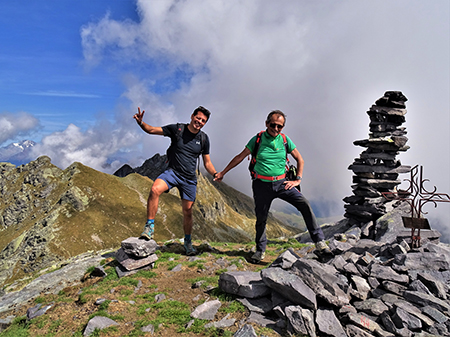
[{"x1": 116, "y1": 237, "x2": 158, "y2": 277}]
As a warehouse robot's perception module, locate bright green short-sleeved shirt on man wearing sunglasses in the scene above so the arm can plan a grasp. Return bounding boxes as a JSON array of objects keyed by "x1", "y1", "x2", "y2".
[{"x1": 245, "y1": 131, "x2": 296, "y2": 181}]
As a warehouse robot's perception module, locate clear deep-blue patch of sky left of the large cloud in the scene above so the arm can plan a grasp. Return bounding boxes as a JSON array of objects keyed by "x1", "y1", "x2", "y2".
[{"x1": 0, "y1": 0, "x2": 137, "y2": 135}]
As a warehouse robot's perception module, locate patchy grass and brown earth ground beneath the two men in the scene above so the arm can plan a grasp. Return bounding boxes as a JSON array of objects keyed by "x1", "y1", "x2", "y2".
[{"x1": 0, "y1": 241, "x2": 312, "y2": 337}]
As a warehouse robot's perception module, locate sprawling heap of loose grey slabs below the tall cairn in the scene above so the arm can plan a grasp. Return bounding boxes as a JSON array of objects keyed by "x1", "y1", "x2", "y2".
[{"x1": 219, "y1": 209, "x2": 450, "y2": 337}]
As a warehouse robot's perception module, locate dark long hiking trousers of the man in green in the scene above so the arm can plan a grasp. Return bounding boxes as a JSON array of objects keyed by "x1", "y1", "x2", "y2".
[{"x1": 252, "y1": 179, "x2": 325, "y2": 252}]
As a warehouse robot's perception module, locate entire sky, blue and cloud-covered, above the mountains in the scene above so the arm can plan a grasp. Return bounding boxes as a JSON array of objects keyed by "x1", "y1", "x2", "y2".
[{"x1": 0, "y1": 0, "x2": 450, "y2": 228}]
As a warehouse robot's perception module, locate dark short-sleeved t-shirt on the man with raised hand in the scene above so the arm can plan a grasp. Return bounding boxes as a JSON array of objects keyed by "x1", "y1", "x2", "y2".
[{"x1": 162, "y1": 124, "x2": 209, "y2": 180}]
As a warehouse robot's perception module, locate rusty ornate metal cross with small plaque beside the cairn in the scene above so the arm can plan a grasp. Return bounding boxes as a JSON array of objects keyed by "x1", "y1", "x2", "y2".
[{"x1": 382, "y1": 165, "x2": 450, "y2": 247}]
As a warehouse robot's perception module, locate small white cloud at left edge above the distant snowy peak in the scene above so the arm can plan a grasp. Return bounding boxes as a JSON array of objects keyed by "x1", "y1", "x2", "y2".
[{"x1": 0, "y1": 111, "x2": 39, "y2": 144}]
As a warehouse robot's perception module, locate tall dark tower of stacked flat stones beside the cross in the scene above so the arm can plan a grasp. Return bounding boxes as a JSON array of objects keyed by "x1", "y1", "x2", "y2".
[{"x1": 343, "y1": 91, "x2": 411, "y2": 223}]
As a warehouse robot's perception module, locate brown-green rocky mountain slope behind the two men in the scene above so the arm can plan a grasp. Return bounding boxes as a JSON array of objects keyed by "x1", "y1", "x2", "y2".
[{"x1": 0, "y1": 156, "x2": 298, "y2": 288}]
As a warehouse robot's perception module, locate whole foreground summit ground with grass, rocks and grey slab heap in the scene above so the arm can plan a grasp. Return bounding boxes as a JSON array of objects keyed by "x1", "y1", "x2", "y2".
[{"x1": 0, "y1": 203, "x2": 450, "y2": 337}]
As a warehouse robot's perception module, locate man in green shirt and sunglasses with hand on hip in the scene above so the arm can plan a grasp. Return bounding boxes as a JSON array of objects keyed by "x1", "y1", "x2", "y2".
[{"x1": 215, "y1": 110, "x2": 330, "y2": 262}]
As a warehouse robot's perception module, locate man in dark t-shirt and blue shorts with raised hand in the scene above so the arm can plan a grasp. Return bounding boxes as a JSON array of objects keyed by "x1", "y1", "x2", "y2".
[{"x1": 133, "y1": 106, "x2": 217, "y2": 255}]
